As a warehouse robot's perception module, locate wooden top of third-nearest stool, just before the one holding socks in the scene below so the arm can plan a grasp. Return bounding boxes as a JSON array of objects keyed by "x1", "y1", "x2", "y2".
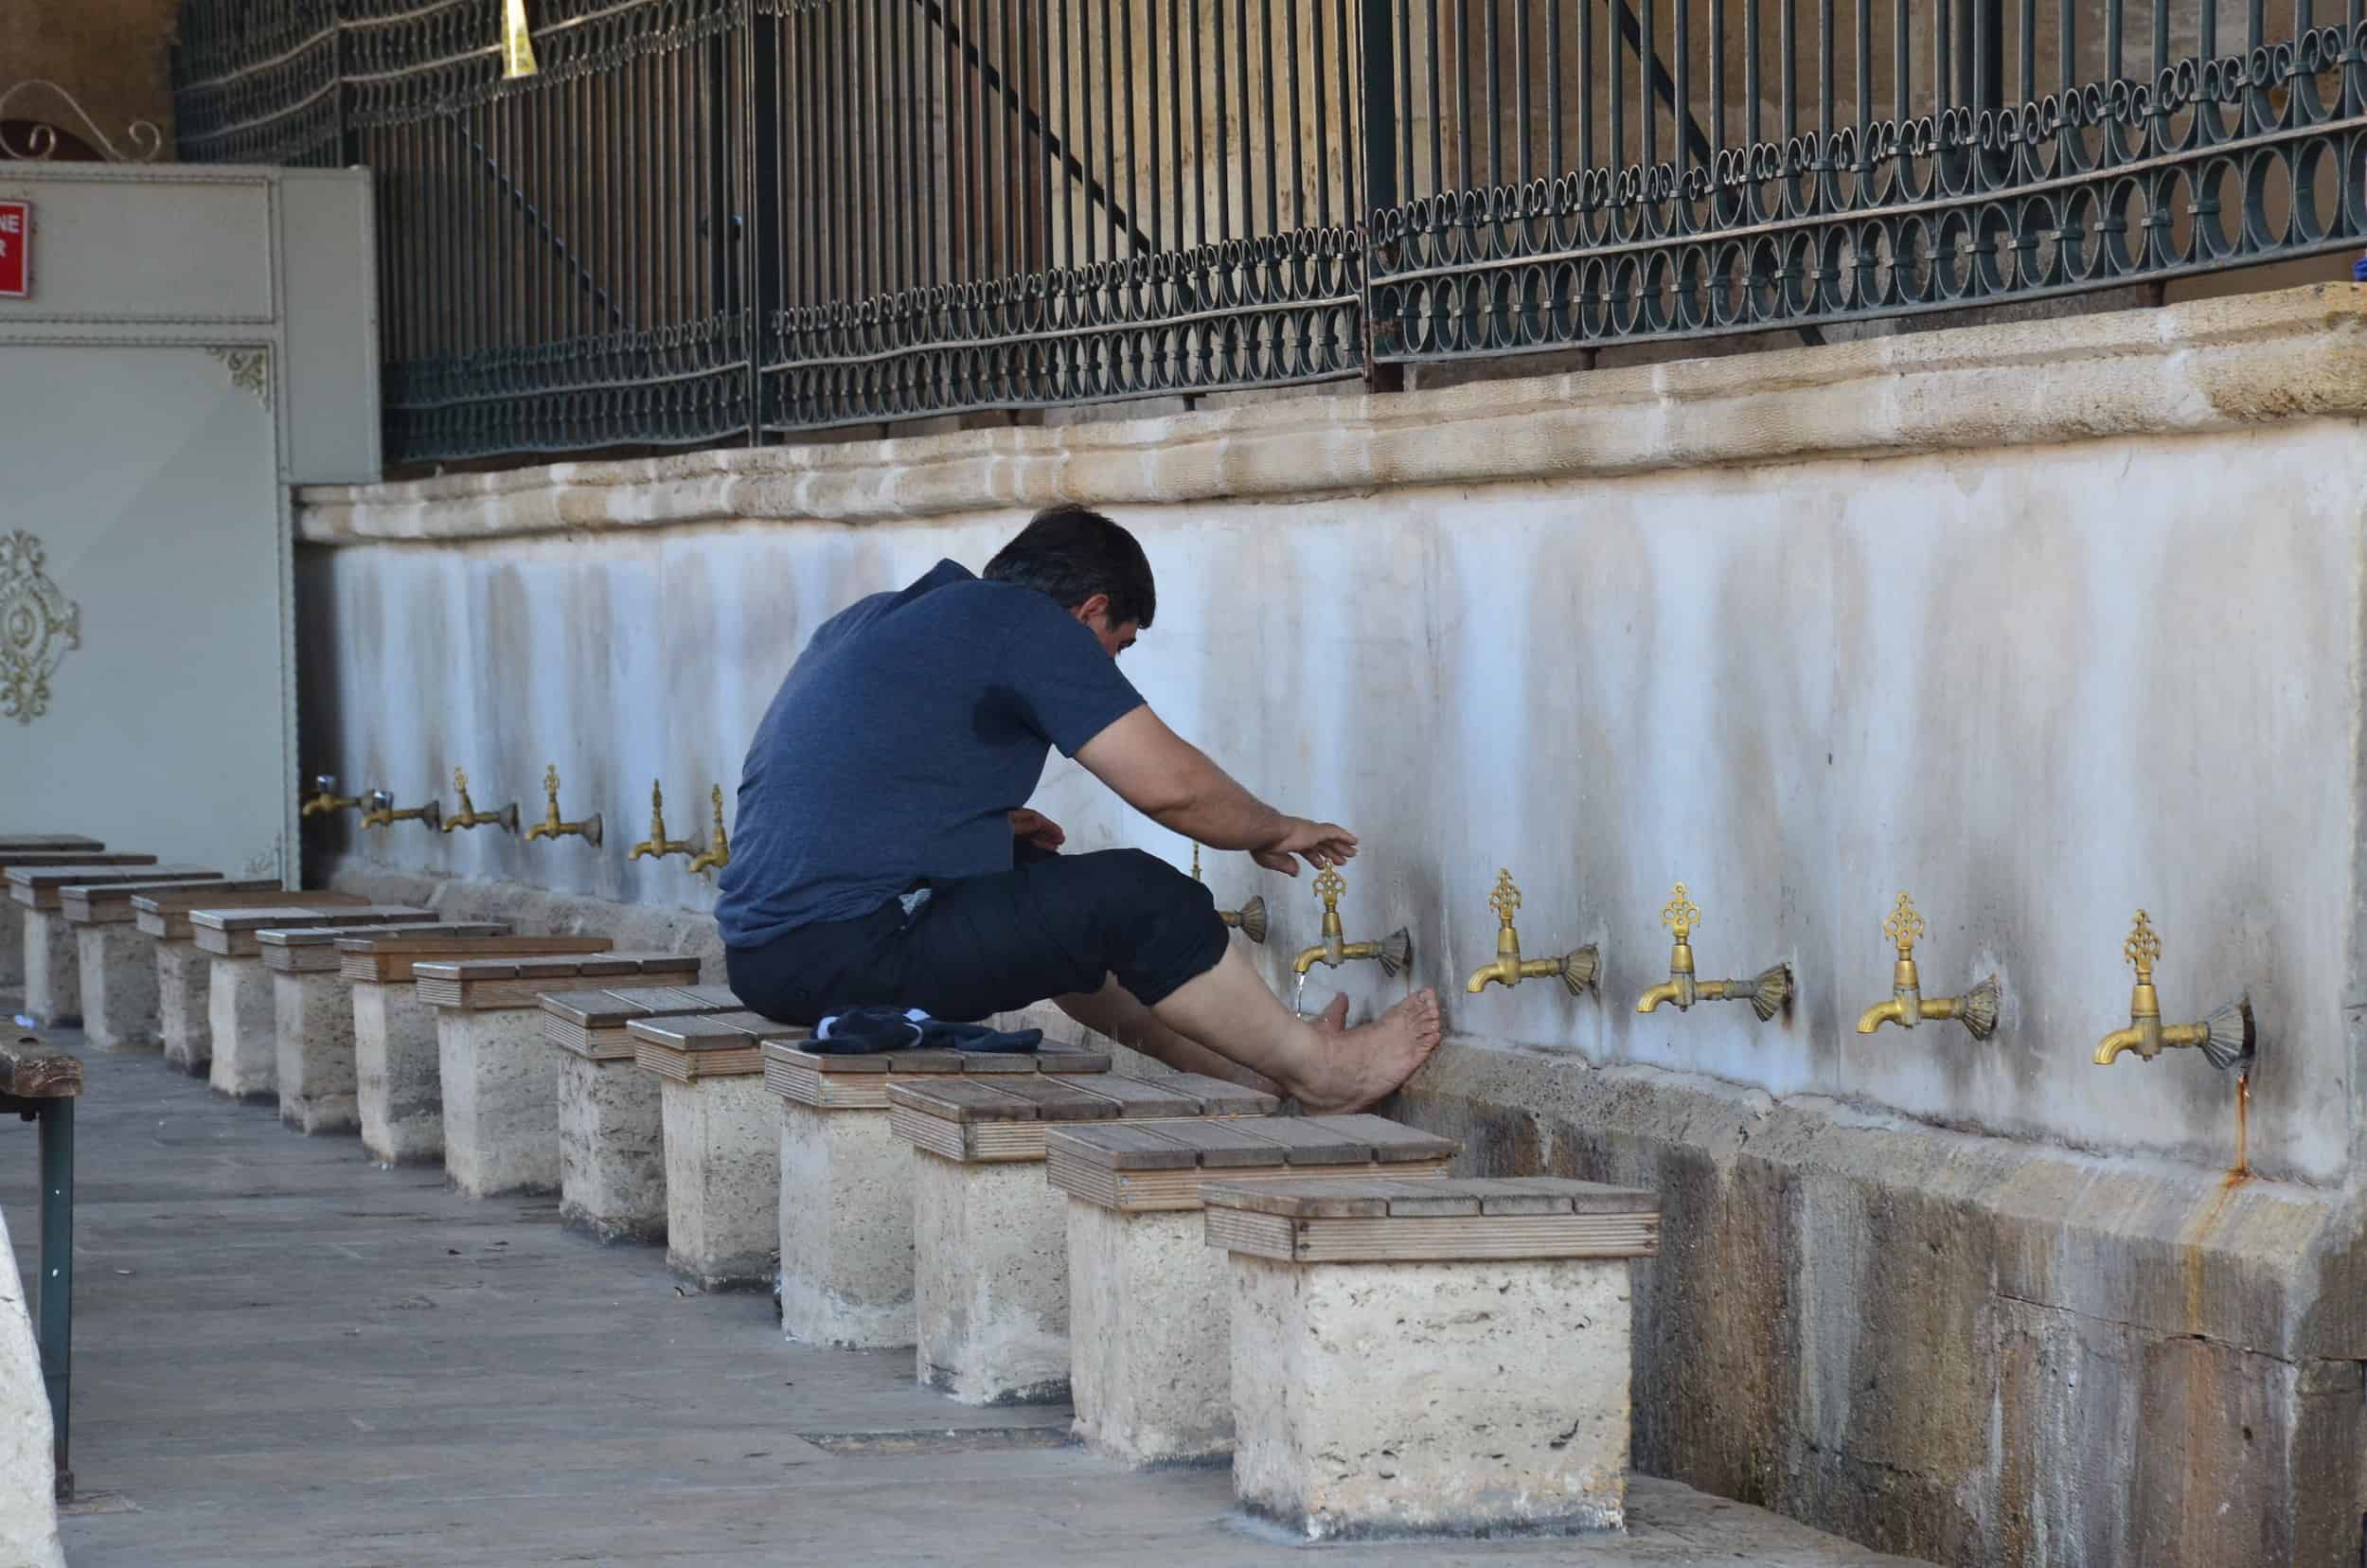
[{"x1": 888, "y1": 1073, "x2": 1281, "y2": 1163}]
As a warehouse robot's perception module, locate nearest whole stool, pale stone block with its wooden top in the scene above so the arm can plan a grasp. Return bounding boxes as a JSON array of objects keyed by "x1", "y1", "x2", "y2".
[{"x1": 1205, "y1": 1180, "x2": 1660, "y2": 1540}]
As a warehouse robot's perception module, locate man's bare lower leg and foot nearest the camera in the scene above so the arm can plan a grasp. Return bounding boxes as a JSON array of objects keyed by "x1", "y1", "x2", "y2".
[{"x1": 1150, "y1": 948, "x2": 1439, "y2": 1111}]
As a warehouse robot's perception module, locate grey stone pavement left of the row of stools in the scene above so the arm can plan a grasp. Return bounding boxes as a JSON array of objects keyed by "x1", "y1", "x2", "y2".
[{"x1": 0, "y1": 1033, "x2": 1906, "y2": 1568}]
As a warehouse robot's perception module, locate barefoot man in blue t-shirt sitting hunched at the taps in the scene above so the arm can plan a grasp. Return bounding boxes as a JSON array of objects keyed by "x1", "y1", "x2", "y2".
[{"x1": 715, "y1": 507, "x2": 1439, "y2": 1111}]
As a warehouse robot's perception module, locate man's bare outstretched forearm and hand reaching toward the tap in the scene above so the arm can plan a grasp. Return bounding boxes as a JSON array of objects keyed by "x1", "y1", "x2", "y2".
[{"x1": 1077, "y1": 704, "x2": 1357, "y2": 877}]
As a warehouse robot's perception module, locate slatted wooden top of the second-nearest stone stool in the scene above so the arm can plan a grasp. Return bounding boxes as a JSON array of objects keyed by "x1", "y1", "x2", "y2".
[{"x1": 1044, "y1": 1115, "x2": 1461, "y2": 1213}]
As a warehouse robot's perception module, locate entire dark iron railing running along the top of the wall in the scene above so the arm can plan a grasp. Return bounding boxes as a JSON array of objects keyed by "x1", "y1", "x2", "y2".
[{"x1": 175, "y1": 0, "x2": 2367, "y2": 459}]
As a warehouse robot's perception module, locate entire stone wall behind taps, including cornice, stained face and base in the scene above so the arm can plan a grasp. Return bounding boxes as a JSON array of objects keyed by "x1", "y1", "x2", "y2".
[{"x1": 298, "y1": 287, "x2": 2367, "y2": 1563}]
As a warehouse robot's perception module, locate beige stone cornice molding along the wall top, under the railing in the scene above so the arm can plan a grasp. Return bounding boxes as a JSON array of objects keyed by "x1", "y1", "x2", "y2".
[{"x1": 301, "y1": 284, "x2": 2367, "y2": 544}]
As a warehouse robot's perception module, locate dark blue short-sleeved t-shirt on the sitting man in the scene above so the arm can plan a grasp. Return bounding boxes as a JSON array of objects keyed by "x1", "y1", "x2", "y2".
[{"x1": 715, "y1": 561, "x2": 1144, "y2": 948}]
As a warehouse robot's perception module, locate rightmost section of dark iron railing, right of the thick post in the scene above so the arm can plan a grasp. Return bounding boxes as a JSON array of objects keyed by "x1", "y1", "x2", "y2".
[{"x1": 1368, "y1": 0, "x2": 2367, "y2": 360}]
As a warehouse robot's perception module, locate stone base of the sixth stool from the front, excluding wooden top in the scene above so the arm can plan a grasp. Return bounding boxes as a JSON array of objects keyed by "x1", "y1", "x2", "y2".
[{"x1": 552, "y1": 1042, "x2": 666, "y2": 1241}]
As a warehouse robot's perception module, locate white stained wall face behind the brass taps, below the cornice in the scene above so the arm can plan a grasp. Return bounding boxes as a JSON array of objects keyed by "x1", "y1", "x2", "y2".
[{"x1": 306, "y1": 404, "x2": 2367, "y2": 1182}]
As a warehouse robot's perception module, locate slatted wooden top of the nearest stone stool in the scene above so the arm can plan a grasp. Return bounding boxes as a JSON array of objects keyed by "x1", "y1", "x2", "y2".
[{"x1": 1201, "y1": 1177, "x2": 1660, "y2": 1262}]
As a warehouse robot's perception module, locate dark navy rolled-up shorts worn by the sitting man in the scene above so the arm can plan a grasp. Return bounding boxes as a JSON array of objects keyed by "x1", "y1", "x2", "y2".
[{"x1": 724, "y1": 850, "x2": 1226, "y2": 1025}]
